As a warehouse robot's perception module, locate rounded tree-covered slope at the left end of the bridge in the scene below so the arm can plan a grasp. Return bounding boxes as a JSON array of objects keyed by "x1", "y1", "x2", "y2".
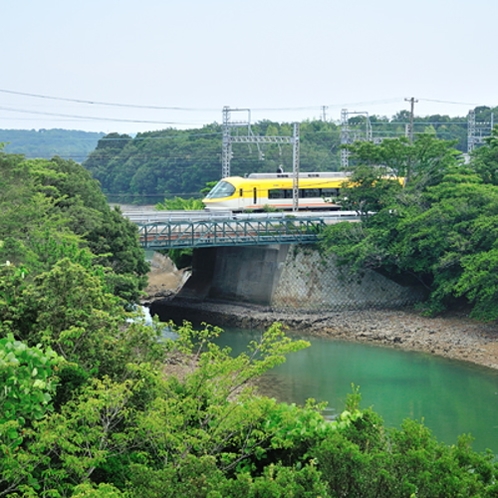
[{"x1": 0, "y1": 153, "x2": 149, "y2": 302}]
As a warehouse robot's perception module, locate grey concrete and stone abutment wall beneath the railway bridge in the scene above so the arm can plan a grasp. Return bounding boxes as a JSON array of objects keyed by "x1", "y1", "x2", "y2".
[{"x1": 173, "y1": 244, "x2": 423, "y2": 311}]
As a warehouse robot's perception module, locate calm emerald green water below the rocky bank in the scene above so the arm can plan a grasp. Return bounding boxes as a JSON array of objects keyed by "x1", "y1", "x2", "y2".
[{"x1": 215, "y1": 330, "x2": 498, "y2": 454}]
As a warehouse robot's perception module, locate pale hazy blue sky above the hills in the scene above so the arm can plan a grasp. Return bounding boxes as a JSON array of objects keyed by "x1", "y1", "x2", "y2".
[{"x1": 0, "y1": 0, "x2": 498, "y2": 133}]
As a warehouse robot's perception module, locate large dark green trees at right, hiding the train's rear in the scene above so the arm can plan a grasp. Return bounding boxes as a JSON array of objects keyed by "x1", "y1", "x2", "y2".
[{"x1": 322, "y1": 132, "x2": 498, "y2": 320}]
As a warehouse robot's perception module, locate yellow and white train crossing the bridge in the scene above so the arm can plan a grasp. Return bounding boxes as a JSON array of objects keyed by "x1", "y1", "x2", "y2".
[{"x1": 202, "y1": 172, "x2": 348, "y2": 212}]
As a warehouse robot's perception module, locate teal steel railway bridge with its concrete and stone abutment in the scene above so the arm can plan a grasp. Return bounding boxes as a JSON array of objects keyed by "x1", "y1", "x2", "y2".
[{"x1": 124, "y1": 211, "x2": 420, "y2": 313}]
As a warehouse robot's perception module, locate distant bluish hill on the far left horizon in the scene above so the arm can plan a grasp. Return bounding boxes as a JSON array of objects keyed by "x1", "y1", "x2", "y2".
[{"x1": 0, "y1": 129, "x2": 104, "y2": 163}]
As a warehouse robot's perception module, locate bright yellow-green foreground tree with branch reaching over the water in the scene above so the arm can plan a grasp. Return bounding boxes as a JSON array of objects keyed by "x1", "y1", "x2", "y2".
[{"x1": 131, "y1": 324, "x2": 312, "y2": 470}]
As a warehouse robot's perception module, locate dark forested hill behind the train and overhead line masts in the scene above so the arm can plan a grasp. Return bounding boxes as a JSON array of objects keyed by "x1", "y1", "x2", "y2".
[{"x1": 83, "y1": 107, "x2": 494, "y2": 204}]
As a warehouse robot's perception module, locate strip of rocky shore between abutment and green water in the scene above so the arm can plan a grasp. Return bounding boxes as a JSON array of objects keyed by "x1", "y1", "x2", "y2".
[{"x1": 150, "y1": 297, "x2": 498, "y2": 369}]
